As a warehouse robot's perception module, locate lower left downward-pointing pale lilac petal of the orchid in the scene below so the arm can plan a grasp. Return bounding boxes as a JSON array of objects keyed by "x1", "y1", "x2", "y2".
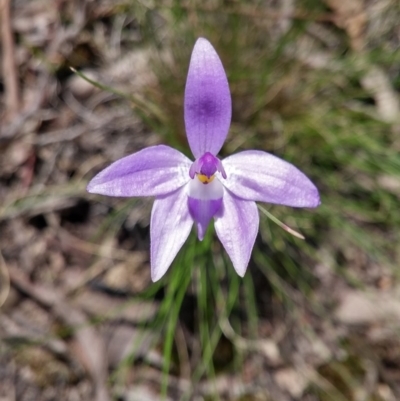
[{"x1": 150, "y1": 186, "x2": 193, "y2": 281}]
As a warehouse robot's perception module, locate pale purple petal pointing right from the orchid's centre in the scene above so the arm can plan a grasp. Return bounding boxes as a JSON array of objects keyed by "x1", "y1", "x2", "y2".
[{"x1": 222, "y1": 150, "x2": 320, "y2": 207}]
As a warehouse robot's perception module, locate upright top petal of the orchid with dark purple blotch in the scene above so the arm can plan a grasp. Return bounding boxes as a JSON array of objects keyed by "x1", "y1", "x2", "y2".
[{"x1": 185, "y1": 38, "x2": 232, "y2": 159}]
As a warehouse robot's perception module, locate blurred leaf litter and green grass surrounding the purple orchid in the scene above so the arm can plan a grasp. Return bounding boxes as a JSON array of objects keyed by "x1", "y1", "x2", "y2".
[{"x1": 0, "y1": 0, "x2": 400, "y2": 401}]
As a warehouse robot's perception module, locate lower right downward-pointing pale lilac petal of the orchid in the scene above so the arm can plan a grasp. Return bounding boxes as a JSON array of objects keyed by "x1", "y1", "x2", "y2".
[{"x1": 215, "y1": 190, "x2": 260, "y2": 277}]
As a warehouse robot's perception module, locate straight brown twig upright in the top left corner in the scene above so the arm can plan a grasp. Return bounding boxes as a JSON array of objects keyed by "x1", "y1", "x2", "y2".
[{"x1": 0, "y1": 0, "x2": 19, "y2": 119}]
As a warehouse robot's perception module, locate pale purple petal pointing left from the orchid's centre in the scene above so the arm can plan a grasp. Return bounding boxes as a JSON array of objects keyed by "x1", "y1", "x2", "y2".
[{"x1": 87, "y1": 145, "x2": 192, "y2": 196}]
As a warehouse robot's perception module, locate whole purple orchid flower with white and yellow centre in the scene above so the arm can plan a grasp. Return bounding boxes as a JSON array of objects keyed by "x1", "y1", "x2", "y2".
[{"x1": 87, "y1": 38, "x2": 320, "y2": 281}]
